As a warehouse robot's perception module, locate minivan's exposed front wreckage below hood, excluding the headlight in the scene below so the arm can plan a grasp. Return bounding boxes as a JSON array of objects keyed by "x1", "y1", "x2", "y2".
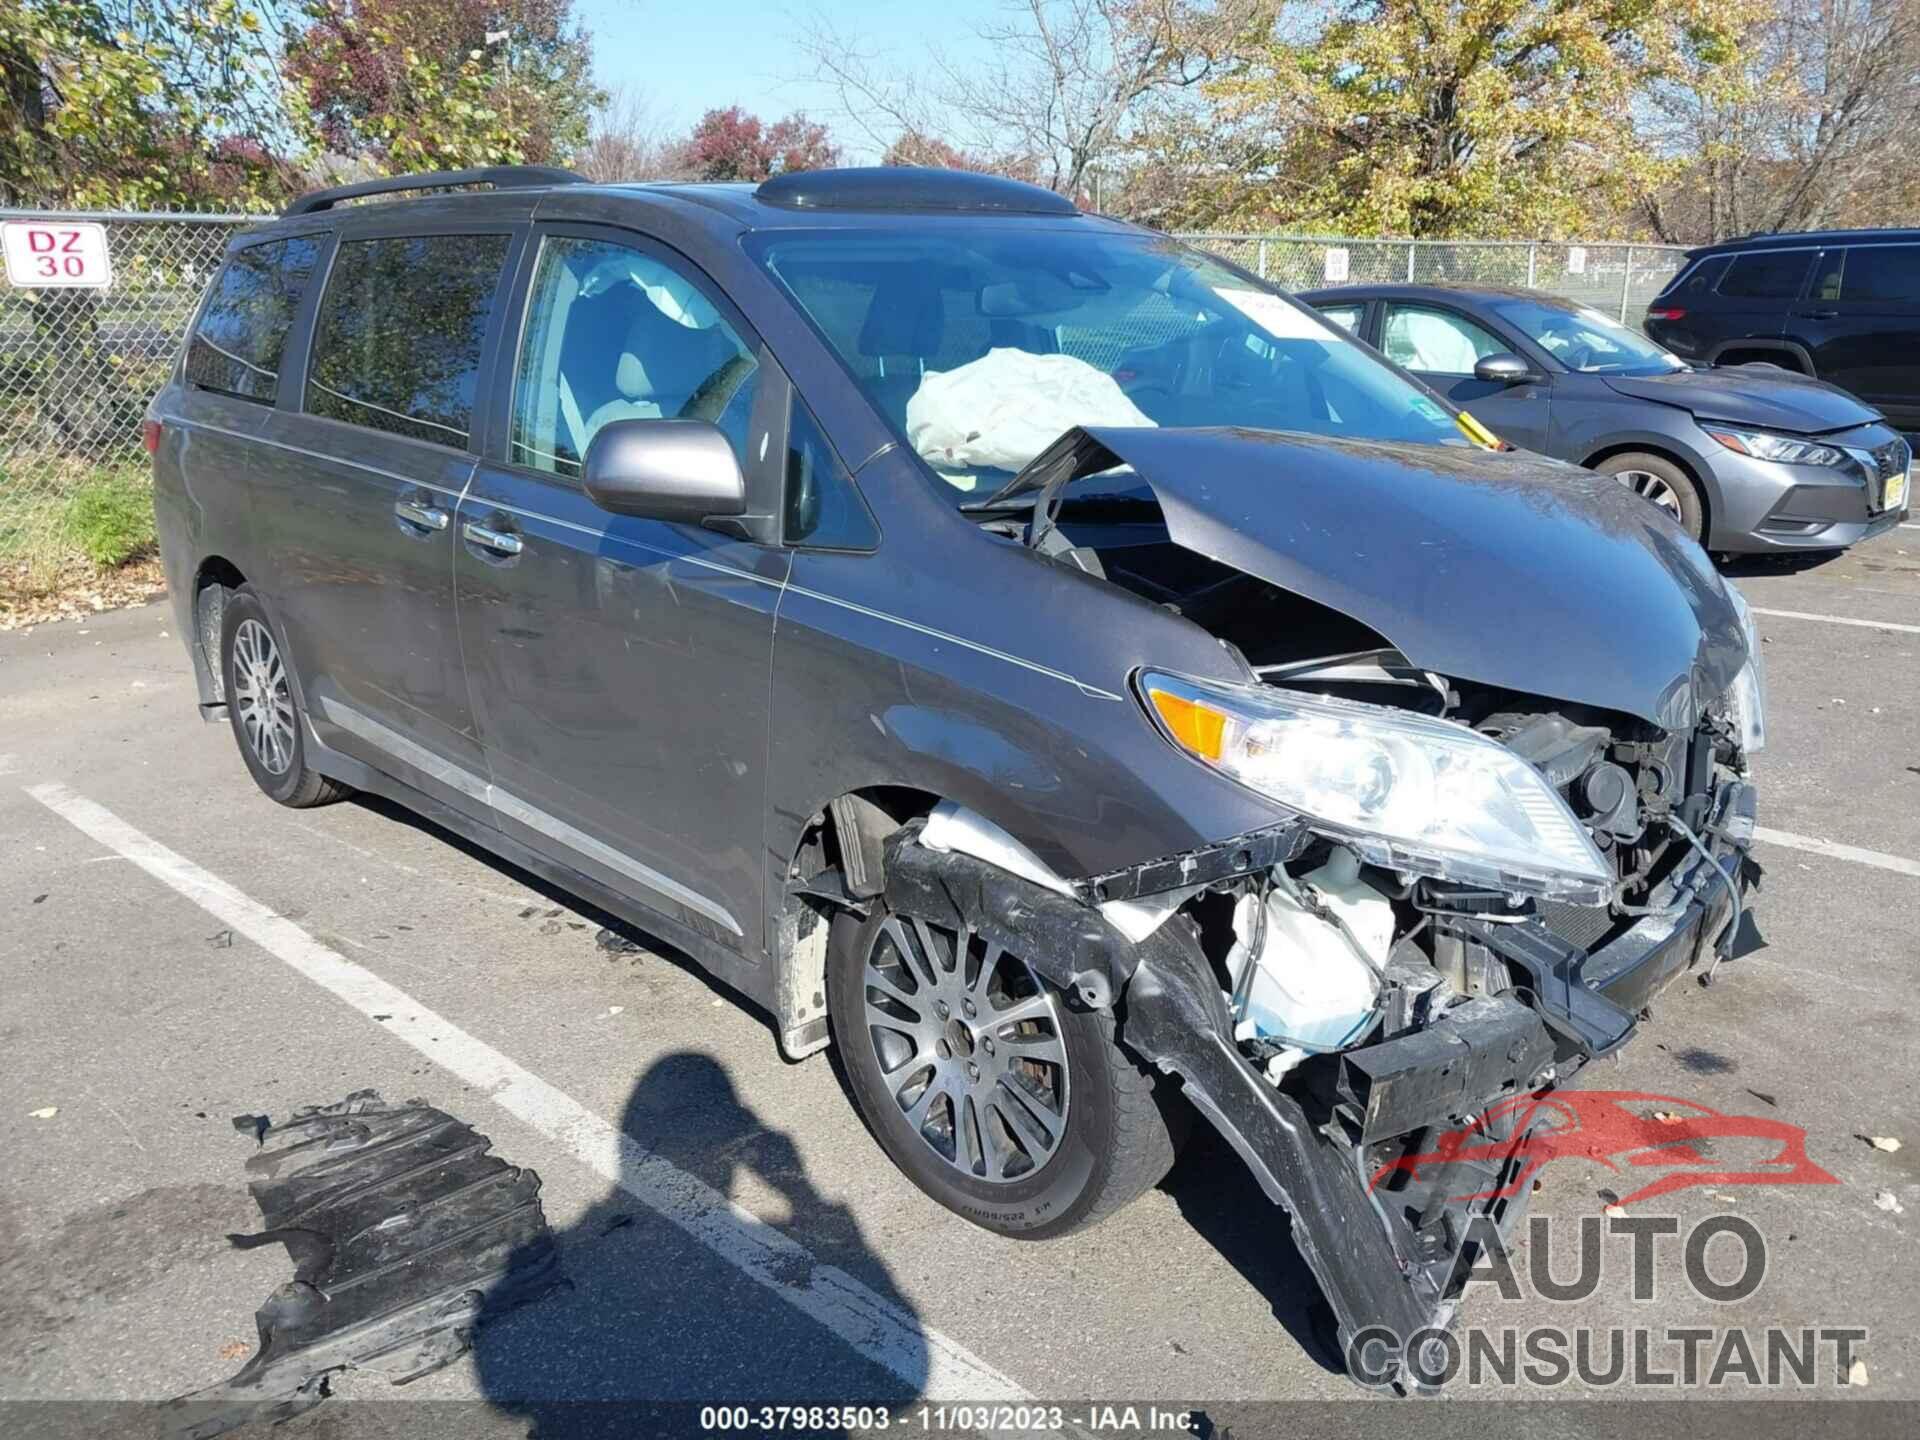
[{"x1": 885, "y1": 697, "x2": 1757, "y2": 1382}]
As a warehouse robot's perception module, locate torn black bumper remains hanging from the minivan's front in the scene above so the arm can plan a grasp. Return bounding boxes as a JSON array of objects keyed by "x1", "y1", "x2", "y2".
[{"x1": 885, "y1": 780, "x2": 1757, "y2": 1384}]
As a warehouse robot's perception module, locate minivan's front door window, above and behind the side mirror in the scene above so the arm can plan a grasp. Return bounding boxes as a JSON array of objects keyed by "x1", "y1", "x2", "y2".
[{"x1": 509, "y1": 236, "x2": 758, "y2": 476}]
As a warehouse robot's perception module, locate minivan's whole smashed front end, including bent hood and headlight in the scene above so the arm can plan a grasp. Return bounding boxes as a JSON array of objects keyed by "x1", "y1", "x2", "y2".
[{"x1": 885, "y1": 428, "x2": 1764, "y2": 1386}]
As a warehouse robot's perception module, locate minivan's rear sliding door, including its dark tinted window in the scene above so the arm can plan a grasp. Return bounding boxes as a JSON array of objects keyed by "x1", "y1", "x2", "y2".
[{"x1": 253, "y1": 225, "x2": 515, "y2": 814}]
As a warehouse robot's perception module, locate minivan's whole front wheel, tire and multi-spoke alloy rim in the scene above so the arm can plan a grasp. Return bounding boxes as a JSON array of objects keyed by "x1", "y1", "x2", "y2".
[{"x1": 828, "y1": 900, "x2": 1183, "y2": 1240}]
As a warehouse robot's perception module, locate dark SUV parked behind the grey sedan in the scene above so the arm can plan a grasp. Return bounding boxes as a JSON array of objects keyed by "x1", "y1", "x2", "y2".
[{"x1": 1645, "y1": 230, "x2": 1920, "y2": 432}]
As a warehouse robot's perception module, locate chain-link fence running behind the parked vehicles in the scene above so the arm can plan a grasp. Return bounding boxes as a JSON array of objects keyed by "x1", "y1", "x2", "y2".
[{"x1": 0, "y1": 209, "x2": 1680, "y2": 597}]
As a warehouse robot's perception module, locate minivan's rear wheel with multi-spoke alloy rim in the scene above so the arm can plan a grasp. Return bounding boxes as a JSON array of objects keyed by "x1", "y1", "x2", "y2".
[{"x1": 221, "y1": 586, "x2": 353, "y2": 810}]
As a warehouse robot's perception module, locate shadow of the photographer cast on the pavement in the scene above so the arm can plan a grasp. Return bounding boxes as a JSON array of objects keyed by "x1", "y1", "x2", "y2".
[{"x1": 474, "y1": 1050, "x2": 927, "y2": 1440}]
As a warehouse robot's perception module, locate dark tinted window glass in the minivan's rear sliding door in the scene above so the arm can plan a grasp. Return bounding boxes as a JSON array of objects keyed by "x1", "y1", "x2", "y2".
[{"x1": 307, "y1": 234, "x2": 507, "y2": 449}]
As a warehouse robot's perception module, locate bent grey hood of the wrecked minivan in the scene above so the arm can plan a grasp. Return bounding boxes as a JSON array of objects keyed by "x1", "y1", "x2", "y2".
[{"x1": 1008, "y1": 428, "x2": 1747, "y2": 730}]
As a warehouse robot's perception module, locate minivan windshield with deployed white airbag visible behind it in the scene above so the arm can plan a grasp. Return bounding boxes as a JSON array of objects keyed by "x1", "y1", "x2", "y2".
[{"x1": 749, "y1": 227, "x2": 1469, "y2": 497}]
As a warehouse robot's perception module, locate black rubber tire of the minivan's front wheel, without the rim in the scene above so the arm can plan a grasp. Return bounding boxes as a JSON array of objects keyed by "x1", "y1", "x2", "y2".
[{"x1": 828, "y1": 900, "x2": 1187, "y2": 1240}]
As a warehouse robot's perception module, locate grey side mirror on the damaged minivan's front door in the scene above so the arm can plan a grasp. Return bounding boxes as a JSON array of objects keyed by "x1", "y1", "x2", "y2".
[{"x1": 582, "y1": 420, "x2": 747, "y2": 524}]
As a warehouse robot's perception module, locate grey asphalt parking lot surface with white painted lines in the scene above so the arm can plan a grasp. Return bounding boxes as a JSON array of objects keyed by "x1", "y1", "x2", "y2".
[{"x1": 0, "y1": 526, "x2": 1920, "y2": 1434}]
